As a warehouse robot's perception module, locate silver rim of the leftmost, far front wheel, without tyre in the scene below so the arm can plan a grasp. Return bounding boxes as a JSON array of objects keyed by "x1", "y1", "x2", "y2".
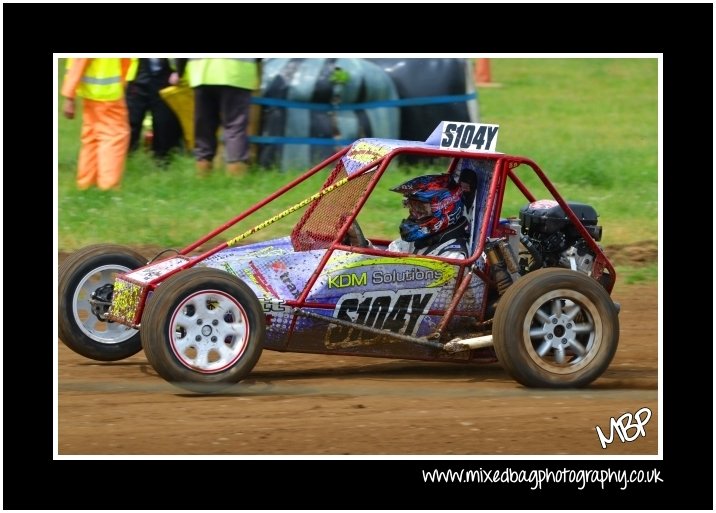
[{"x1": 72, "y1": 265, "x2": 137, "y2": 344}]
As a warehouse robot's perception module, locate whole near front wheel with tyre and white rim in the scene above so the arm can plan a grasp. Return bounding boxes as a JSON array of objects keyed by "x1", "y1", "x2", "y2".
[{"x1": 140, "y1": 267, "x2": 266, "y2": 393}]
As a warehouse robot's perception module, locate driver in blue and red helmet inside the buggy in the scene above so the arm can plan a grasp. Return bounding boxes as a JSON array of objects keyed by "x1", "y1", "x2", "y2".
[{"x1": 388, "y1": 174, "x2": 469, "y2": 258}]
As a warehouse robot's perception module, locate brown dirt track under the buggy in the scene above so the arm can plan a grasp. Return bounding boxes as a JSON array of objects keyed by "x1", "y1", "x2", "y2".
[{"x1": 58, "y1": 245, "x2": 659, "y2": 456}]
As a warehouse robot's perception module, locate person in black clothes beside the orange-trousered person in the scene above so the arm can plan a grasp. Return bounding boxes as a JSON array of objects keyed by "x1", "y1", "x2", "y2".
[{"x1": 127, "y1": 59, "x2": 183, "y2": 166}]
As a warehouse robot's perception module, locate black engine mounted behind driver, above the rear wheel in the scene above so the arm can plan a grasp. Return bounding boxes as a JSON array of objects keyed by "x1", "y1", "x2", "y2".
[{"x1": 520, "y1": 200, "x2": 602, "y2": 274}]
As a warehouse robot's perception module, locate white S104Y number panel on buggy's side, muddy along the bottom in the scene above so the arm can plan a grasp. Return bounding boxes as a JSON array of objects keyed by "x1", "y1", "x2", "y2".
[{"x1": 325, "y1": 289, "x2": 436, "y2": 349}]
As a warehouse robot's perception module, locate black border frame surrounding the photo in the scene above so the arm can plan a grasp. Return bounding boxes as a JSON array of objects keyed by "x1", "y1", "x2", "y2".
[{"x1": 3, "y1": 4, "x2": 713, "y2": 510}]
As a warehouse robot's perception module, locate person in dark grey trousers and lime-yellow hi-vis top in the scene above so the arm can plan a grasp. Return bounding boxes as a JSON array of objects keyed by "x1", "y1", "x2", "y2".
[{"x1": 177, "y1": 58, "x2": 259, "y2": 176}]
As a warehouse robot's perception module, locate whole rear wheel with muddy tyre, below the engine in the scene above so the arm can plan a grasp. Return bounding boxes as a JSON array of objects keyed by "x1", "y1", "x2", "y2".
[{"x1": 492, "y1": 268, "x2": 619, "y2": 388}]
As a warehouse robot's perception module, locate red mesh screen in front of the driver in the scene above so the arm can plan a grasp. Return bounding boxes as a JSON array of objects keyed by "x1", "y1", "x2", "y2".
[{"x1": 291, "y1": 169, "x2": 373, "y2": 251}]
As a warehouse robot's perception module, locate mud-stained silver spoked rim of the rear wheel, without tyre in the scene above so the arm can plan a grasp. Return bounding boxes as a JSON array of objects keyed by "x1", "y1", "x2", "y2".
[{"x1": 523, "y1": 290, "x2": 603, "y2": 374}]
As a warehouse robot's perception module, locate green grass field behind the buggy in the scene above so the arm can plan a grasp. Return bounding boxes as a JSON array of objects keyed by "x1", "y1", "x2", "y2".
[{"x1": 57, "y1": 58, "x2": 658, "y2": 282}]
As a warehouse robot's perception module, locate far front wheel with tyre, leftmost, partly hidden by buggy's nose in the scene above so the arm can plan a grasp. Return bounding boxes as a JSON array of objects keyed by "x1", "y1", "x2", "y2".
[{"x1": 58, "y1": 244, "x2": 147, "y2": 362}]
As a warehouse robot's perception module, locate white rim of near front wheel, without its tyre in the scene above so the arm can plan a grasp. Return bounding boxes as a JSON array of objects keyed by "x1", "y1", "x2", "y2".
[{"x1": 169, "y1": 290, "x2": 250, "y2": 374}]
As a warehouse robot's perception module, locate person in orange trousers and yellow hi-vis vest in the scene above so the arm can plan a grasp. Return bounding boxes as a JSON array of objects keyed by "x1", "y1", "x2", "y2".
[{"x1": 62, "y1": 58, "x2": 130, "y2": 190}]
